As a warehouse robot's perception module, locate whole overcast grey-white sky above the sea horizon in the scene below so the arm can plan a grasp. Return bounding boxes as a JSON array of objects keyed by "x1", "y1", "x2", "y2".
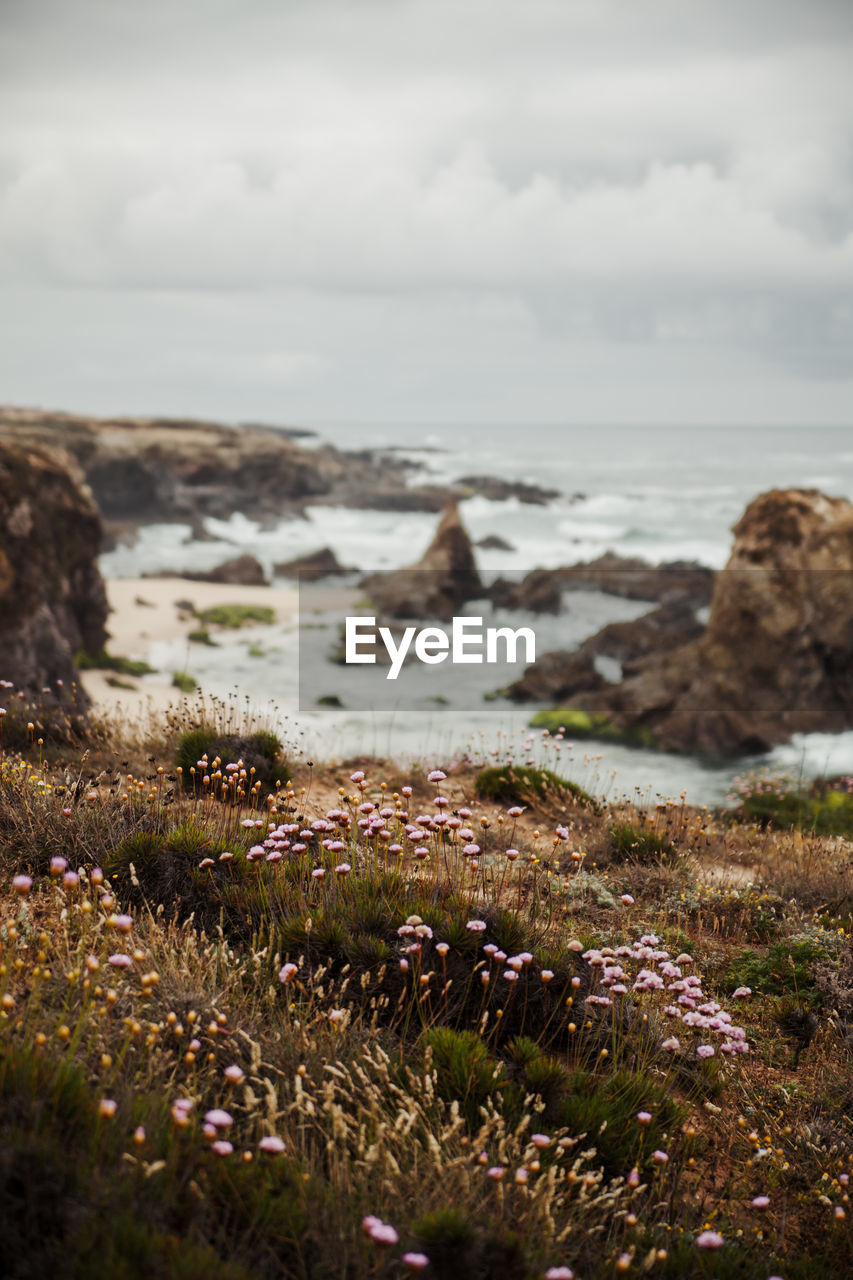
[{"x1": 0, "y1": 0, "x2": 853, "y2": 425}]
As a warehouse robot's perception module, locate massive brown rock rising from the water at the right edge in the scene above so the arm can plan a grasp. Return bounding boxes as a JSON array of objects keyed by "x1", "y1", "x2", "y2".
[{"x1": 596, "y1": 489, "x2": 853, "y2": 755}]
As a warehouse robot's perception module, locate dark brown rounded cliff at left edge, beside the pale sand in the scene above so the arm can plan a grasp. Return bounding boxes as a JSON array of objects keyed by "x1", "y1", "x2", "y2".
[{"x1": 0, "y1": 442, "x2": 108, "y2": 692}]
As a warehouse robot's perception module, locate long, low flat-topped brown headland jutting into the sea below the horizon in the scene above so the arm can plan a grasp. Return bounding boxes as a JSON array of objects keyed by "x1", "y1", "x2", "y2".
[{"x1": 0, "y1": 407, "x2": 563, "y2": 539}]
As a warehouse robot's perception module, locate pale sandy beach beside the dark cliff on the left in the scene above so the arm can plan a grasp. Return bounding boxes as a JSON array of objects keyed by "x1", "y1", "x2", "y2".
[{"x1": 81, "y1": 577, "x2": 298, "y2": 723}]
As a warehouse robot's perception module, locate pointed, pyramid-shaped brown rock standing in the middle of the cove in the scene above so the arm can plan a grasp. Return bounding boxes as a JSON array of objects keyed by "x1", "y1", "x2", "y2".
[{"x1": 361, "y1": 502, "x2": 484, "y2": 621}]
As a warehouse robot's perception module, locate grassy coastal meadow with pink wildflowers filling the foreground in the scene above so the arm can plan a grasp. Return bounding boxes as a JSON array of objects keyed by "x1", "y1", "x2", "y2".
[{"x1": 0, "y1": 690, "x2": 853, "y2": 1280}]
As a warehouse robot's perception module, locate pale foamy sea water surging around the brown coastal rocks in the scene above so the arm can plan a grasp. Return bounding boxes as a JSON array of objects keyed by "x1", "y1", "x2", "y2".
[{"x1": 101, "y1": 422, "x2": 853, "y2": 805}]
